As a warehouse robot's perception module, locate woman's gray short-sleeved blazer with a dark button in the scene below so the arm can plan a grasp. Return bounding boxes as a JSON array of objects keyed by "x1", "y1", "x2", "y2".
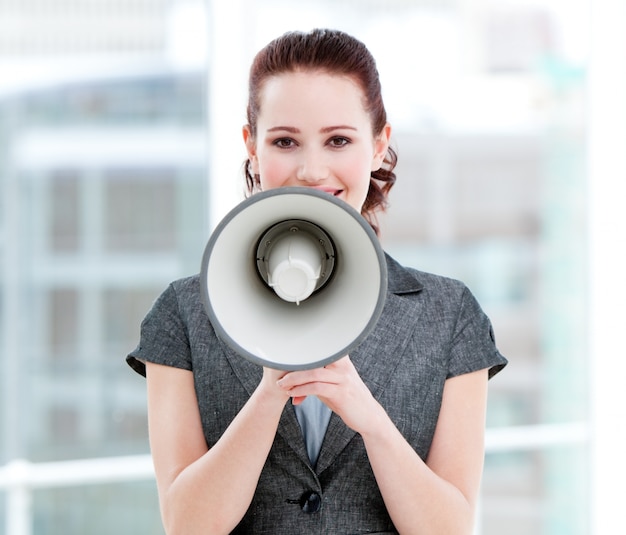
[{"x1": 127, "y1": 257, "x2": 506, "y2": 535}]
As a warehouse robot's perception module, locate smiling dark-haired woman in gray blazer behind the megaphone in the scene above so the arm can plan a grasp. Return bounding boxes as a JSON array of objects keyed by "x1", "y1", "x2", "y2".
[{"x1": 128, "y1": 30, "x2": 506, "y2": 535}]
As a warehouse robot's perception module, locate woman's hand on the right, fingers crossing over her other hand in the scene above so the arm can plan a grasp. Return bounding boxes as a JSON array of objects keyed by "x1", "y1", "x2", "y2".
[{"x1": 278, "y1": 355, "x2": 380, "y2": 432}]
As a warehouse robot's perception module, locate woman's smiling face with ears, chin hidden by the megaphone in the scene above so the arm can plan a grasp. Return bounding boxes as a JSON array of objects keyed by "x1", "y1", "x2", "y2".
[{"x1": 244, "y1": 71, "x2": 391, "y2": 212}]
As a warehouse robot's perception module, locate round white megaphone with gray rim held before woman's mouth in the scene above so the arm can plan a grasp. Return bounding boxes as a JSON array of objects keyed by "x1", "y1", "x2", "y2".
[{"x1": 200, "y1": 187, "x2": 387, "y2": 371}]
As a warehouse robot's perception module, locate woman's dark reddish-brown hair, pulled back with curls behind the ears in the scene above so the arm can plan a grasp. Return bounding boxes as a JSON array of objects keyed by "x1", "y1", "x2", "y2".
[{"x1": 244, "y1": 29, "x2": 398, "y2": 232}]
